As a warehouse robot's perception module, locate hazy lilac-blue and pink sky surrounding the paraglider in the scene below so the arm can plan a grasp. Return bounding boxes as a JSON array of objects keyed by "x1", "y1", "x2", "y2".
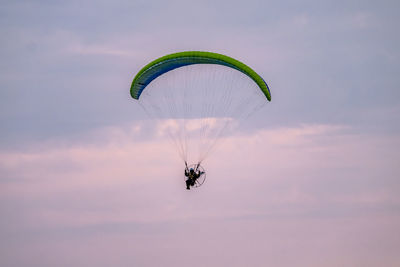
[{"x1": 0, "y1": 0, "x2": 400, "y2": 267}]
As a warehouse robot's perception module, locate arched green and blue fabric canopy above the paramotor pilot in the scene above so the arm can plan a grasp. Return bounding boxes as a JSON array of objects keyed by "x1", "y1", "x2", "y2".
[{"x1": 130, "y1": 51, "x2": 271, "y2": 101}]
